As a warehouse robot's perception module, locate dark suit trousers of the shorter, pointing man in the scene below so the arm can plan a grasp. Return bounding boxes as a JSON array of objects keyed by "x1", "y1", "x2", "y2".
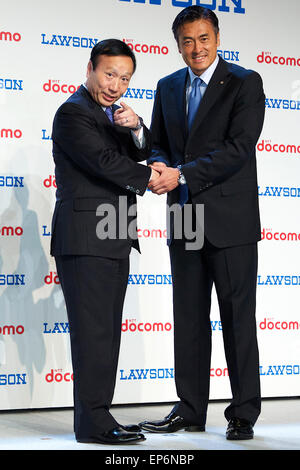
[{"x1": 55, "y1": 256, "x2": 129, "y2": 439}]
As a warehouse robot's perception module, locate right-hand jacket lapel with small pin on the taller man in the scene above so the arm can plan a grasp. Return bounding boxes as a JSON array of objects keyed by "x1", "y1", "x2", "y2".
[{"x1": 188, "y1": 57, "x2": 231, "y2": 141}]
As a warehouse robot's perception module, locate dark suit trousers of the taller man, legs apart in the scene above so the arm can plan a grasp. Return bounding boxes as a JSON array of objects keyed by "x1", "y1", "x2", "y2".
[{"x1": 170, "y1": 239, "x2": 261, "y2": 425}]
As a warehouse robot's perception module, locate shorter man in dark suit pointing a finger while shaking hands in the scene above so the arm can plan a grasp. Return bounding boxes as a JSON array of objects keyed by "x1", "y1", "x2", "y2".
[{"x1": 51, "y1": 39, "x2": 158, "y2": 444}]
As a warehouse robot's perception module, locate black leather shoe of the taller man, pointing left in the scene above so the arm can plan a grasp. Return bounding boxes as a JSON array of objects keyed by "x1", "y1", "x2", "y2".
[{"x1": 139, "y1": 411, "x2": 205, "y2": 433}]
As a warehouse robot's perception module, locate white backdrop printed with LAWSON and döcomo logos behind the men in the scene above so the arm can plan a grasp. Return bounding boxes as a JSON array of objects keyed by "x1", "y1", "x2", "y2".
[{"x1": 0, "y1": 0, "x2": 300, "y2": 409}]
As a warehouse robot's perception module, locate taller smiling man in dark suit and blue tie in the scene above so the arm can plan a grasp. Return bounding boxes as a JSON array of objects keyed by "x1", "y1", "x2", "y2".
[{"x1": 141, "y1": 6, "x2": 265, "y2": 439}]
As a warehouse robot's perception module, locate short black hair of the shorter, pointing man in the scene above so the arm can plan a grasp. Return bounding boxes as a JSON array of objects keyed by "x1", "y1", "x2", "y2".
[{"x1": 90, "y1": 39, "x2": 136, "y2": 72}]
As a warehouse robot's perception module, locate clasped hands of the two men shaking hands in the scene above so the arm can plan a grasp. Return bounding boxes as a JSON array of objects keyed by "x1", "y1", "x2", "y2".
[{"x1": 148, "y1": 162, "x2": 179, "y2": 194}]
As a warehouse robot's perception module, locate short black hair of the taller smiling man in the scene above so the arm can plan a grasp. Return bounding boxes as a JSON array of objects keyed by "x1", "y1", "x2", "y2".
[{"x1": 172, "y1": 5, "x2": 219, "y2": 42}]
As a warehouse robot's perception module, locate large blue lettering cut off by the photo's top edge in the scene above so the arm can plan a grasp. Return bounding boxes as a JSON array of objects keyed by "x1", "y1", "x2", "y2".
[{"x1": 119, "y1": 0, "x2": 246, "y2": 14}]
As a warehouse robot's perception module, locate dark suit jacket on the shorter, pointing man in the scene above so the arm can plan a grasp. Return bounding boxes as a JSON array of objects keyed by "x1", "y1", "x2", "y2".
[{"x1": 51, "y1": 86, "x2": 151, "y2": 258}]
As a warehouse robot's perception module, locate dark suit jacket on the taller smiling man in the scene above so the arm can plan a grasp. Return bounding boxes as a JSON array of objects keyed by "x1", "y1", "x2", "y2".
[{"x1": 148, "y1": 57, "x2": 265, "y2": 247}]
